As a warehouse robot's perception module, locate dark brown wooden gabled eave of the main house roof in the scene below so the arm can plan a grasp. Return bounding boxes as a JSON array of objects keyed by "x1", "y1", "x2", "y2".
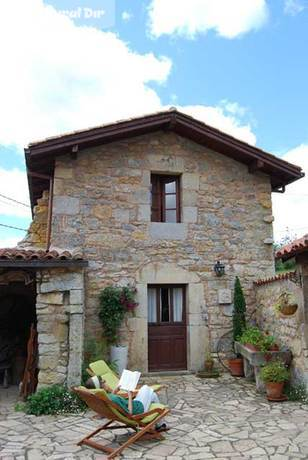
[{"x1": 25, "y1": 110, "x2": 304, "y2": 206}]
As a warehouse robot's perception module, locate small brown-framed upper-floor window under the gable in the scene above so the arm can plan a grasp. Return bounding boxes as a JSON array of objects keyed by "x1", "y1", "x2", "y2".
[{"x1": 151, "y1": 174, "x2": 181, "y2": 222}]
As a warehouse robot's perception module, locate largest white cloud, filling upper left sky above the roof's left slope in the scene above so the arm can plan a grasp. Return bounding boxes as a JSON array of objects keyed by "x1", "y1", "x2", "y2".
[{"x1": 0, "y1": 0, "x2": 171, "y2": 146}]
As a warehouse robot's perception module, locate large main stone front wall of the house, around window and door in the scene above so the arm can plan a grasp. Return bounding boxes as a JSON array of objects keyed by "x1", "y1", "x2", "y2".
[{"x1": 51, "y1": 132, "x2": 274, "y2": 370}]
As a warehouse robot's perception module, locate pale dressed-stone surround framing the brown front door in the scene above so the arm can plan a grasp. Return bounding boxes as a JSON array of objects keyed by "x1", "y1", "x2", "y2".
[{"x1": 128, "y1": 263, "x2": 208, "y2": 372}]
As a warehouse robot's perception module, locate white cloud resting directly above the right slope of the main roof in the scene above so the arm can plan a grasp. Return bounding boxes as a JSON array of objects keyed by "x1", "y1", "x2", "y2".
[{"x1": 179, "y1": 103, "x2": 256, "y2": 145}]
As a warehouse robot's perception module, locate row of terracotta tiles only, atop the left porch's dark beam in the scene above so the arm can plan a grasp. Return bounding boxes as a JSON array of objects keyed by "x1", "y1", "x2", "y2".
[{"x1": 0, "y1": 248, "x2": 83, "y2": 260}]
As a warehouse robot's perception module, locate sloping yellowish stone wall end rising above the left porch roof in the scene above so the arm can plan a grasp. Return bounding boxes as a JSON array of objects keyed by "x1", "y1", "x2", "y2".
[{"x1": 18, "y1": 190, "x2": 49, "y2": 249}]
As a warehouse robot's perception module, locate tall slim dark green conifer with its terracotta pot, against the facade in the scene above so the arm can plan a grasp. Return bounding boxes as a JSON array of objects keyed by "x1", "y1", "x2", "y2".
[{"x1": 228, "y1": 277, "x2": 246, "y2": 377}]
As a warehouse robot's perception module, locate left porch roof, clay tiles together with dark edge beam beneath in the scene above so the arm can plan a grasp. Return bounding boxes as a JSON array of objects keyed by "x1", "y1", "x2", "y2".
[{"x1": 0, "y1": 248, "x2": 88, "y2": 268}]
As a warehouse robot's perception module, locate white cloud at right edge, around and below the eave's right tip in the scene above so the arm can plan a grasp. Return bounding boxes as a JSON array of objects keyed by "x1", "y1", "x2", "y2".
[{"x1": 272, "y1": 144, "x2": 308, "y2": 241}]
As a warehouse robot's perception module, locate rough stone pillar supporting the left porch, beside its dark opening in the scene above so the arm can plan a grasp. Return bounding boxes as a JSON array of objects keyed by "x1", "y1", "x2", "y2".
[{"x1": 36, "y1": 268, "x2": 84, "y2": 386}]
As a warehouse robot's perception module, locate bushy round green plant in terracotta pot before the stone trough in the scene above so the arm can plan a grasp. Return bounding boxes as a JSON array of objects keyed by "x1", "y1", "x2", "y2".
[{"x1": 260, "y1": 360, "x2": 290, "y2": 401}]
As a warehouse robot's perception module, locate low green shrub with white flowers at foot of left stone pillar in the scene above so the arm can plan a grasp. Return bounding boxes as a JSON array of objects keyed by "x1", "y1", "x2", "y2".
[{"x1": 22, "y1": 385, "x2": 86, "y2": 415}]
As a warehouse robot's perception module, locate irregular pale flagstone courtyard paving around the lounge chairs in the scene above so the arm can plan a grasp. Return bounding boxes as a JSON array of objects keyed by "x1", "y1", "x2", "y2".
[{"x1": 0, "y1": 375, "x2": 308, "y2": 460}]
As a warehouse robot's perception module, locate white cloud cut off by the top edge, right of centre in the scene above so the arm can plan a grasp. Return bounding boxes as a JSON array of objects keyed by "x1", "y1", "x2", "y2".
[{"x1": 149, "y1": 0, "x2": 268, "y2": 38}]
